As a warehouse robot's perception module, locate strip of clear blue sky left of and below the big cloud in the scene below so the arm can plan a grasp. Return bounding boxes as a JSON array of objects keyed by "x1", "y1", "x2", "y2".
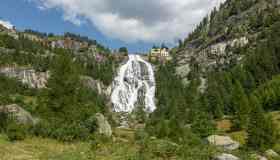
[{"x1": 0, "y1": 0, "x2": 153, "y2": 52}]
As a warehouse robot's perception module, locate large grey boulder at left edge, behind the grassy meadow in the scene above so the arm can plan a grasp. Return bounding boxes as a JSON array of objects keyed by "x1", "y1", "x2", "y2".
[{"x1": 0, "y1": 104, "x2": 36, "y2": 125}]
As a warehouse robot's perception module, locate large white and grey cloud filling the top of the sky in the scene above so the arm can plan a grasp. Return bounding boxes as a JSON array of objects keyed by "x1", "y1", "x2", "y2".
[{"x1": 30, "y1": 0, "x2": 224, "y2": 43}]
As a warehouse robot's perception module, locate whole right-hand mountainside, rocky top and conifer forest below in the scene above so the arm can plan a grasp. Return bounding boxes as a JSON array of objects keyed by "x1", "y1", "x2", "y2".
[{"x1": 145, "y1": 0, "x2": 280, "y2": 159}]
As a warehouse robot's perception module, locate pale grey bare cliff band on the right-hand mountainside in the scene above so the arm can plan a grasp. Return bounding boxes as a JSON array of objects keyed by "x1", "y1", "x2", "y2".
[{"x1": 176, "y1": 37, "x2": 249, "y2": 82}]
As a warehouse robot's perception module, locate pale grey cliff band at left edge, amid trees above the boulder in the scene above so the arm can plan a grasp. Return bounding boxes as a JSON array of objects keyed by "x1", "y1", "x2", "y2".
[{"x1": 0, "y1": 67, "x2": 50, "y2": 89}]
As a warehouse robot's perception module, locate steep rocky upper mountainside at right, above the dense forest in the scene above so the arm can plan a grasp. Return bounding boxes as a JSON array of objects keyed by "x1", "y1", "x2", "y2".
[{"x1": 174, "y1": 0, "x2": 280, "y2": 84}]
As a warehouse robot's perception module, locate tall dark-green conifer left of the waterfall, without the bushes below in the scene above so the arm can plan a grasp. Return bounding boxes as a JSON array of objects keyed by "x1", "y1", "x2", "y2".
[{"x1": 48, "y1": 50, "x2": 80, "y2": 111}]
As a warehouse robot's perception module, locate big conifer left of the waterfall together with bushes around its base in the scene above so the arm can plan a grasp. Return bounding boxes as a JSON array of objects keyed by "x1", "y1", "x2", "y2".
[{"x1": 29, "y1": 50, "x2": 105, "y2": 141}]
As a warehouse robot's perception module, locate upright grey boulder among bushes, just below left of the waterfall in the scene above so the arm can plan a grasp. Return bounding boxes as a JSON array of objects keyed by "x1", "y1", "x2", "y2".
[{"x1": 95, "y1": 113, "x2": 112, "y2": 137}]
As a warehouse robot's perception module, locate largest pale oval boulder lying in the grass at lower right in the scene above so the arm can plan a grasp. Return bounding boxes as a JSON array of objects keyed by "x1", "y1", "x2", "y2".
[{"x1": 207, "y1": 135, "x2": 240, "y2": 150}]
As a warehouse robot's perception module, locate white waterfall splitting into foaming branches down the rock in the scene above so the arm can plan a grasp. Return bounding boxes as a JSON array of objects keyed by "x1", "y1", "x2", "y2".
[{"x1": 111, "y1": 55, "x2": 156, "y2": 113}]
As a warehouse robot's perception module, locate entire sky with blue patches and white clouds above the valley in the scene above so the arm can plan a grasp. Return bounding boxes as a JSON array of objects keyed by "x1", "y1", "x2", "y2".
[{"x1": 0, "y1": 0, "x2": 224, "y2": 52}]
